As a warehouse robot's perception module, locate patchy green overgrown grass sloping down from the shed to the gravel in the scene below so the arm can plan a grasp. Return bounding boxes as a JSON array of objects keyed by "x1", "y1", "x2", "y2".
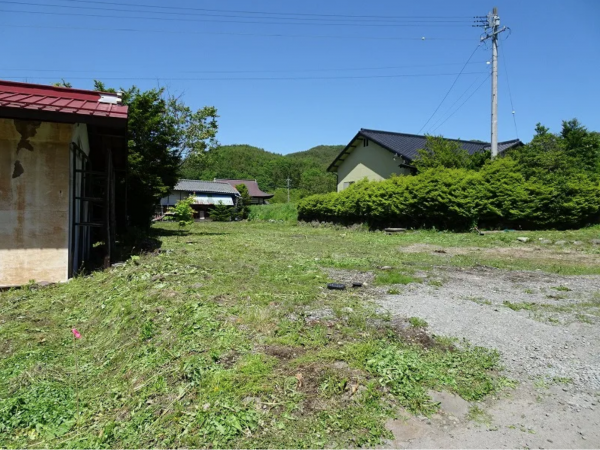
[{"x1": 0, "y1": 221, "x2": 598, "y2": 448}]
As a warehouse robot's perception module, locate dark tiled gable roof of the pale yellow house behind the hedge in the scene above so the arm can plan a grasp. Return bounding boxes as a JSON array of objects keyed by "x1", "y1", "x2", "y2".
[{"x1": 327, "y1": 128, "x2": 522, "y2": 172}]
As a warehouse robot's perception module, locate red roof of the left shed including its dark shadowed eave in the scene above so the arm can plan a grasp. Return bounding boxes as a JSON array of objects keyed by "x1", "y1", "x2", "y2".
[{"x1": 0, "y1": 80, "x2": 127, "y2": 124}]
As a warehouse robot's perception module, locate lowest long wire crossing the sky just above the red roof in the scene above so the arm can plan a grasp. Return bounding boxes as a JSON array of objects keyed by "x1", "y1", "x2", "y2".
[{"x1": 1, "y1": 72, "x2": 484, "y2": 81}]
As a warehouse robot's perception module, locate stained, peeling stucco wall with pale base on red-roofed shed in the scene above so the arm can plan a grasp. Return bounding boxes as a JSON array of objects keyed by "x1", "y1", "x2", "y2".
[{"x1": 0, "y1": 119, "x2": 73, "y2": 286}]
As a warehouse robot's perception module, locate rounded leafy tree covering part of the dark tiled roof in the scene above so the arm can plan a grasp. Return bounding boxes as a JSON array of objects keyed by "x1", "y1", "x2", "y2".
[{"x1": 413, "y1": 135, "x2": 471, "y2": 172}]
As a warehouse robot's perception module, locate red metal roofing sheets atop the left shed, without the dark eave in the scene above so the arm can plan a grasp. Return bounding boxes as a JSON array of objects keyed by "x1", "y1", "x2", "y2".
[{"x1": 0, "y1": 80, "x2": 127, "y2": 119}]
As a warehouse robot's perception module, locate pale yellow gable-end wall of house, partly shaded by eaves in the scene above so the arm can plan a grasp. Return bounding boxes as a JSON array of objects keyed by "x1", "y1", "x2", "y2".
[{"x1": 338, "y1": 141, "x2": 410, "y2": 192}]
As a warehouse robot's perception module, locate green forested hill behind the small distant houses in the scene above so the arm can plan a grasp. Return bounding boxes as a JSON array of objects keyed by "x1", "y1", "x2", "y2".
[{"x1": 181, "y1": 145, "x2": 343, "y2": 202}]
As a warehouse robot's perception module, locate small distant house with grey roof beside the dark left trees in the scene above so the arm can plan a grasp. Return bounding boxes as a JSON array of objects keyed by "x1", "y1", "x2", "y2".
[{"x1": 157, "y1": 179, "x2": 240, "y2": 220}]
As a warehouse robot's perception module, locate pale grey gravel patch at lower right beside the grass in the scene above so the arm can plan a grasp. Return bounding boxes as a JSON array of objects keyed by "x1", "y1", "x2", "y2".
[{"x1": 330, "y1": 266, "x2": 600, "y2": 448}]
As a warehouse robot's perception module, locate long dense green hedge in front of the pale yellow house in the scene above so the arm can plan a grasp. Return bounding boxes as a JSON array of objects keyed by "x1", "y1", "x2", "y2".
[{"x1": 298, "y1": 158, "x2": 600, "y2": 230}]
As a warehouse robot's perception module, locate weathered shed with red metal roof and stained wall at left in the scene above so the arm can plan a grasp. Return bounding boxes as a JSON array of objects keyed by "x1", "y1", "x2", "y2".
[{"x1": 0, "y1": 80, "x2": 127, "y2": 287}]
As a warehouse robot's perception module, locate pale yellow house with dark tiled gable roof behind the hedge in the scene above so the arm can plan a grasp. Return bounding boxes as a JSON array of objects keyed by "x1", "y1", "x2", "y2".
[{"x1": 327, "y1": 128, "x2": 523, "y2": 192}]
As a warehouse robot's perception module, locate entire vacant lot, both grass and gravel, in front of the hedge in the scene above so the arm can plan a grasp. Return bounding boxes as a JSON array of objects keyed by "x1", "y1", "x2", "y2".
[{"x1": 0, "y1": 222, "x2": 600, "y2": 448}]
